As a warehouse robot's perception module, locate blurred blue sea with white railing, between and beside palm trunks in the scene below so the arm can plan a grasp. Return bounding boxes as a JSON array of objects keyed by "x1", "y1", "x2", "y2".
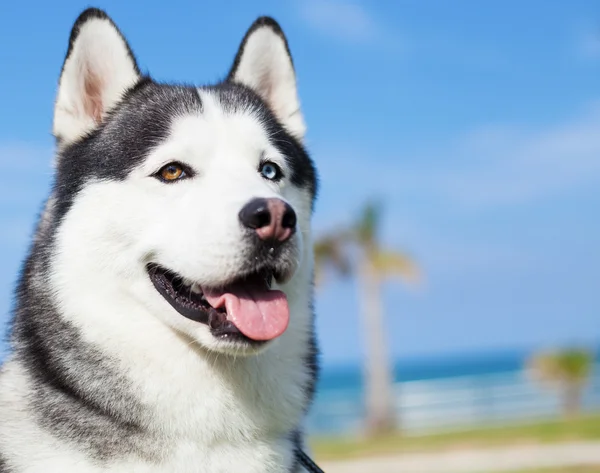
[{"x1": 307, "y1": 352, "x2": 600, "y2": 435}]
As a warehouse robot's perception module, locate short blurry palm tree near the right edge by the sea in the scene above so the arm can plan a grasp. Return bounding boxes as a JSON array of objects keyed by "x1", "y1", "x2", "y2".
[{"x1": 528, "y1": 348, "x2": 593, "y2": 417}]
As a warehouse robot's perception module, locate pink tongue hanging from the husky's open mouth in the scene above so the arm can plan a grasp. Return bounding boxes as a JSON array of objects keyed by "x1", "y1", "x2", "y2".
[{"x1": 204, "y1": 286, "x2": 290, "y2": 340}]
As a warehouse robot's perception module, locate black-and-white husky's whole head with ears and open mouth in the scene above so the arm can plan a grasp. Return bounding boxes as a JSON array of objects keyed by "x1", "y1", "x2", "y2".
[{"x1": 48, "y1": 9, "x2": 316, "y2": 352}]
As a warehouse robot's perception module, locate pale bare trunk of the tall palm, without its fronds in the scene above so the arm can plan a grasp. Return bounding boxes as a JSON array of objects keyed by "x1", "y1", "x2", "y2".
[{"x1": 358, "y1": 262, "x2": 397, "y2": 435}]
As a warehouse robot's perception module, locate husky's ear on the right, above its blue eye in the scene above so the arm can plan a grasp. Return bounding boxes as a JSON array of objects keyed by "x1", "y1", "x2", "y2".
[{"x1": 227, "y1": 17, "x2": 306, "y2": 140}]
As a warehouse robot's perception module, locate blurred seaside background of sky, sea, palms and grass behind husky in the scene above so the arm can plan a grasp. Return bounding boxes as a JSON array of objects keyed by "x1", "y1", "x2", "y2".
[{"x1": 0, "y1": 0, "x2": 600, "y2": 473}]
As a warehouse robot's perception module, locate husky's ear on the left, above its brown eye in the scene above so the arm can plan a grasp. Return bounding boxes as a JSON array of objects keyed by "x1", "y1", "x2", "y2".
[{"x1": 53, "y1": 8, "x2": 140, "y2": 145}]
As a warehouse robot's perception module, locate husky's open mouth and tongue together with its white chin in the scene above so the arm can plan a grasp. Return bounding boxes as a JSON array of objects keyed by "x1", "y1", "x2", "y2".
[{"x1": 146, "y1": 263, "x2": 292, "y2": 356}]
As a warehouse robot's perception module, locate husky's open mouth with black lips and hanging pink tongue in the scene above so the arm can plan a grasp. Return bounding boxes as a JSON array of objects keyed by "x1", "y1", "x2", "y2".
[{"x1": 147, "y1": 264, "x2": 290, "y2": 344}]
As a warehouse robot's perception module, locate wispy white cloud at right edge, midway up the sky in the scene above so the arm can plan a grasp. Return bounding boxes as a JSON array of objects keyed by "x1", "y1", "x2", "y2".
[{"x1": 424, "y1": 107, "x2": 600, "y2": 207}]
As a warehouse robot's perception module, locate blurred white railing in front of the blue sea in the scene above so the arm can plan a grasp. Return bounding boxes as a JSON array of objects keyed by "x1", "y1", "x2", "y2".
[{"x1": 308, "y1": 368, "x2": 600, "y2": 434}]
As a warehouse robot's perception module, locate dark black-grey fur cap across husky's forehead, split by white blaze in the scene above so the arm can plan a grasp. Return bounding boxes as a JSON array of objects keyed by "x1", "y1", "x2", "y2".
[{"x1": 54, "y1": 77, "x2": 318, "y2": 219}]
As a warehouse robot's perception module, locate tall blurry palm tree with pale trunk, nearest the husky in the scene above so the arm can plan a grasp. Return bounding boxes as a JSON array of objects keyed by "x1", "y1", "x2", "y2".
[{"x1": 315, "y1": 202, "x2": 417, "y2": 434}]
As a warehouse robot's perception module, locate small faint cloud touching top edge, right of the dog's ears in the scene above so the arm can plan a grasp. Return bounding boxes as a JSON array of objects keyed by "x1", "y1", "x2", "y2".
[{"x1": 298, "y1": 0, "x2": 381, "y2": 43}]
